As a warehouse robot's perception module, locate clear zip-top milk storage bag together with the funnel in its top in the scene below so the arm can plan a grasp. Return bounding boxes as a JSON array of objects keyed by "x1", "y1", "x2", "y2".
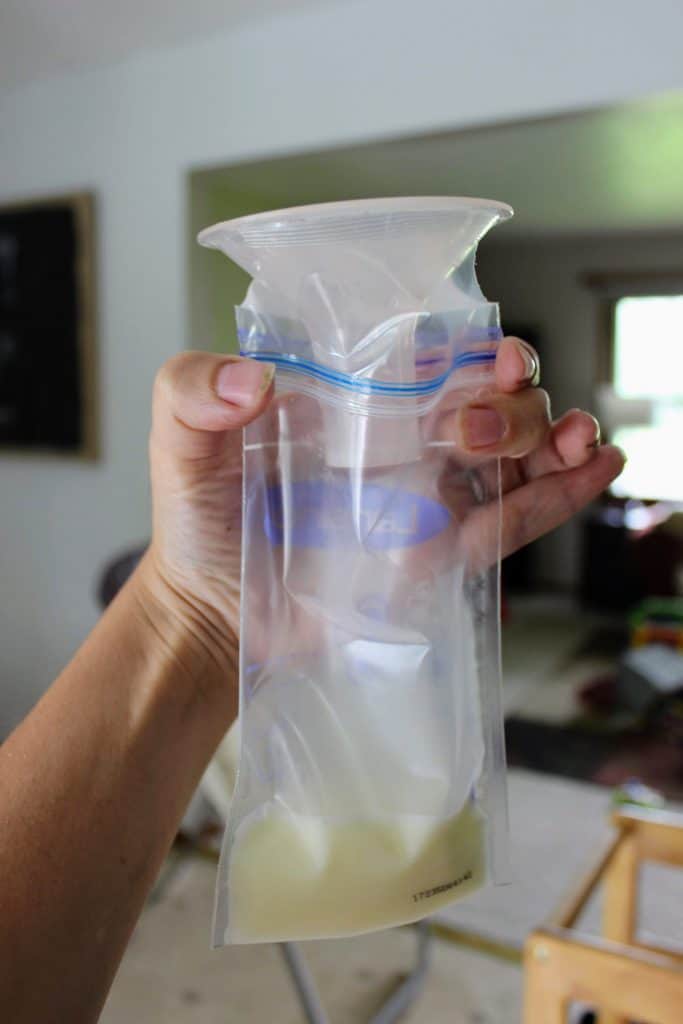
[{"x1": 200, "y1": 198, "x2": 512, "y2": 945}]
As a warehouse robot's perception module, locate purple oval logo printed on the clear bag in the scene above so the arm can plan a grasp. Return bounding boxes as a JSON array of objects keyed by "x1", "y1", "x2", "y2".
[{"x1": 263, "y1": 480, "x2": 451, "y2": 551}]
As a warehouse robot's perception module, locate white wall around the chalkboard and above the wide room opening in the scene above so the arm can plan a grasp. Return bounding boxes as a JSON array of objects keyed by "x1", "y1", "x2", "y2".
[{"x1": 0, "y1": 0, "x2": 683, "y2": 732}]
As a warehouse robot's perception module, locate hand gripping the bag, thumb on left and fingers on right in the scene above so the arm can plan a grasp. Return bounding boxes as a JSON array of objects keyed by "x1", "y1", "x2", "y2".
[{"x1": 141, "y1": 338, "x2": 624, "y2": 666}]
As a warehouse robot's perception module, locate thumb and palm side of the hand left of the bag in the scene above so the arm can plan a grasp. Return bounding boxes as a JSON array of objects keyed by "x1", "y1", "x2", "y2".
[{"x1": 138, "y1": 352, "x2": 274, "y2": 680}]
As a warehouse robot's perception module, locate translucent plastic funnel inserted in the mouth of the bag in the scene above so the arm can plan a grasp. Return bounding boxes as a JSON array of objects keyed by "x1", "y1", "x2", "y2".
[{"x1": 199, "y1": 197, "x2": 512, "y2": 466}]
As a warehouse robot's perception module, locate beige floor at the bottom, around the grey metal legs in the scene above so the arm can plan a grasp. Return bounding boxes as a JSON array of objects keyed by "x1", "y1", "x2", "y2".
[{"x1": 101, "y1": 859, "x2": 521, "y2": 1024}]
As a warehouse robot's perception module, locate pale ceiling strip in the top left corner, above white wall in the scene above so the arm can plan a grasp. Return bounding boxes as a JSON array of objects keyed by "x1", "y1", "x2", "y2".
[{"x1": 0, "y1": 0, "x2": 321, "y2": 90}]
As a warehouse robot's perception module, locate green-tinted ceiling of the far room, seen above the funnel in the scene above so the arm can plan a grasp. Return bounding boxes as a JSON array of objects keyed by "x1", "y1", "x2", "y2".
[{"x1": 193, "y1": 93, "x2": 683, "y2": 239}]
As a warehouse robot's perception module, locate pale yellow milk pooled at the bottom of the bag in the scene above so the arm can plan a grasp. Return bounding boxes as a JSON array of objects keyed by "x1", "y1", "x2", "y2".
[{"x1": 228, "y1": 804, "x2": 485, "y2": 943}]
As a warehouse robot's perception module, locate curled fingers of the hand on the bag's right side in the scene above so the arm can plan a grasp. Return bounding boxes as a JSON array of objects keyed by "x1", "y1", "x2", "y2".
[{"x1": 440, "y1": 338, "x2": 626, "y2": 568}]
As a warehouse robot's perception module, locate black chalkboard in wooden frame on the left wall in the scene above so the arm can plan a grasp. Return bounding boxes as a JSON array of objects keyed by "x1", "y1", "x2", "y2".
[{"x1": 0, "y1": 194, "x2": 97, "y2": 459}]
